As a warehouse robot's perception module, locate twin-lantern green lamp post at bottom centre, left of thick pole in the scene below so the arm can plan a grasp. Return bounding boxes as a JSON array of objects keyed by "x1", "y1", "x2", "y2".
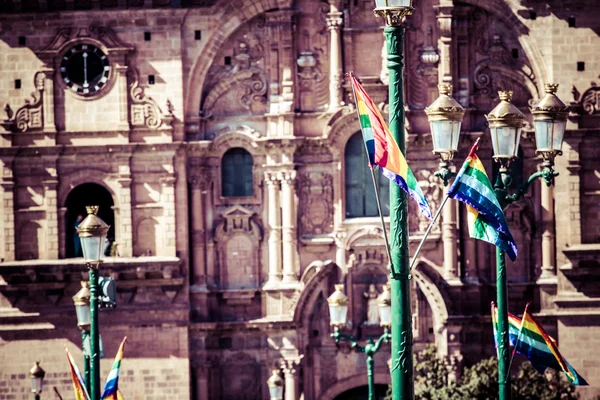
[{"x1": 327, "y1": 285, "x2": 392, "y2": 400}]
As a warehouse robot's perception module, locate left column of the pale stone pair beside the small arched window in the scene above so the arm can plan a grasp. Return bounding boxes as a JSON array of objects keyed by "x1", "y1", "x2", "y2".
[{"x1": 265, "y1": 172, "x2": 282, "y2": 288}]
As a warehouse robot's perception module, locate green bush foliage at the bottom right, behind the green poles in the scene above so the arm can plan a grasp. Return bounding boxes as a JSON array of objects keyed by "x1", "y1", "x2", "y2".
[{"x1": 386, "y1": 346, "x2": 579, "y2": 400}]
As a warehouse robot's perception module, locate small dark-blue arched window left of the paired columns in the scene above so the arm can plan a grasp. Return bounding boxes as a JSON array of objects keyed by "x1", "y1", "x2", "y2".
[{"x1": 221, "y1": 147, "x2": 254, "y2": 197}]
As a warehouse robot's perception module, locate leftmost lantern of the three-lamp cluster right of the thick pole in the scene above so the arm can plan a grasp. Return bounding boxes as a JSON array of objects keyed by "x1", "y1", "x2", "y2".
[{"x1": 425, "y1": 84, "x2": 465, "y2": 186}]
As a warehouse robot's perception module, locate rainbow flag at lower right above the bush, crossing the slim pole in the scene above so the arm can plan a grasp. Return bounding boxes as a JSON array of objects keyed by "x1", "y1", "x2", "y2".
[{"x1": 492, "y1": 303, "x2": 588, "y2": 386}]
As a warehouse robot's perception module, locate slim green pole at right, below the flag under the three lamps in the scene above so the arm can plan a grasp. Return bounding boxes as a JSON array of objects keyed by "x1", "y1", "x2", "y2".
[{"x1": 496, "y1": 247, "x2": 510, "y2": 400}]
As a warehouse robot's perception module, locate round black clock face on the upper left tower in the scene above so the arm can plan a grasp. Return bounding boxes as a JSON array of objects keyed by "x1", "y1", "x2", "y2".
[{"x1": 60, "y1": 44, "x2": 110, "y2": 95}]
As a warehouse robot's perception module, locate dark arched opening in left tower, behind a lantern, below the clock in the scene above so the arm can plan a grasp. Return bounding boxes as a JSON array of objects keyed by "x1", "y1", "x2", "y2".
[{"x1": 65, "y1": 183, "x2": 115, "y2": 258}]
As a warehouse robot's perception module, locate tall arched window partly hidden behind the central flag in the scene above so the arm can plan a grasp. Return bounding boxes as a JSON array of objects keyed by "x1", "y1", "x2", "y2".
[{"x1": 344, "y1": 132, "x2": 390, "y2": 218}]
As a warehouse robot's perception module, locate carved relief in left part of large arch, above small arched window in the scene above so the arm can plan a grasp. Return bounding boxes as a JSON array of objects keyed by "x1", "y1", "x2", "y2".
[{"x1": 200, "y1": 17, "x2": 269, "y2": 118}]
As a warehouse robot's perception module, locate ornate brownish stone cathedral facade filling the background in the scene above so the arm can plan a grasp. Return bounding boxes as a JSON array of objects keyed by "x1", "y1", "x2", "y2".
[{"x1": 0, "y1": 0, "x2": 600, "y2": 400}]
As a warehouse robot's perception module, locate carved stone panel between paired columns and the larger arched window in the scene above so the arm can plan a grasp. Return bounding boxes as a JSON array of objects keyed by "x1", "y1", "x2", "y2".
[{"x1": 299, "y1": 172, "x2": 333, "y2": 235}]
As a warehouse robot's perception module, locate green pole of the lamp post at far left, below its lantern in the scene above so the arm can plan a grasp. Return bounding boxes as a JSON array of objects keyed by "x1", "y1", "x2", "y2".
[{"x1": 89, "y1": 264, "x2": 100, "y2": 400}]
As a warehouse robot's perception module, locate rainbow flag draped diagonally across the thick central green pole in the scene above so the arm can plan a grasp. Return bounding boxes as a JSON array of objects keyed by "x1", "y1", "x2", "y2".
[{"x1": 349, "y1": 74, "x2": 431, "y2": 219}]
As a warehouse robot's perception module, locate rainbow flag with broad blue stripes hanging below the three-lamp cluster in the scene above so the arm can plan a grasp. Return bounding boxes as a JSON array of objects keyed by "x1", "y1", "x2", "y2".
[{"x1": 448, "y1": 139, "x2": 517, "y2": 261}]
